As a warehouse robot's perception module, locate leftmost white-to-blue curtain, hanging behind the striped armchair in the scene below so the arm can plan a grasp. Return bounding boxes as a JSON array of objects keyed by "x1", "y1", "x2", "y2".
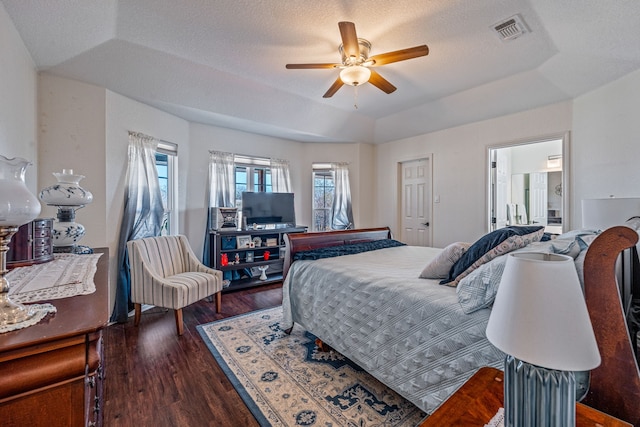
[{"x1": 111, "y1": 132, "x2": 164, "y2": 322}]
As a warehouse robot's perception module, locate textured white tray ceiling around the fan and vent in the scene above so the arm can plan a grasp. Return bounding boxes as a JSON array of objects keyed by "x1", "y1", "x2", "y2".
[{"x1": 2, "y1": 0, "x2": 640, "y2": 143}]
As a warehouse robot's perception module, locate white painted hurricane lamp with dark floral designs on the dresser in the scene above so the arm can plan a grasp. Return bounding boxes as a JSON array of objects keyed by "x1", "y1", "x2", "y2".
[{"x1": 40, "y1": 169, "x2": 93, "y2": 252}]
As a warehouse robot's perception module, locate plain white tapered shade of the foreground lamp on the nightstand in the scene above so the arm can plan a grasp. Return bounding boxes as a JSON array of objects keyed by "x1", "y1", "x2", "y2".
[{"x1": 487, "y1": 252, "x2": 600, "y2": 371}]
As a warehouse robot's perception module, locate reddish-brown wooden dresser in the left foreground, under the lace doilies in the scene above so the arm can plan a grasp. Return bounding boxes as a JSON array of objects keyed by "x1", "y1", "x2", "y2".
[{"x1": 0, "y1": 249, "x2": 109, "y2": 427}]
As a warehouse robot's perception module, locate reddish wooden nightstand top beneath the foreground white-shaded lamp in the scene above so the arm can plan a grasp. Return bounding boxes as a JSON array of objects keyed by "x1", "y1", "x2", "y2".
[{"x1": 419, "y1": 367, "x2": 632, "y2": 427}]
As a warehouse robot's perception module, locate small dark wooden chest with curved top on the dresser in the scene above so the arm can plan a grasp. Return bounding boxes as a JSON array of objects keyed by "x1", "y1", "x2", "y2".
[{"x1": 7, "y1": 218, "x2": 53, "y2": 269}]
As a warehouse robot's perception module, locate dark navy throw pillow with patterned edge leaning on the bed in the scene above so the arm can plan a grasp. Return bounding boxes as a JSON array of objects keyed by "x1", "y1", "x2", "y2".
[{"x1": 440, "y1": 226, "x2": 544, "y2": 286}]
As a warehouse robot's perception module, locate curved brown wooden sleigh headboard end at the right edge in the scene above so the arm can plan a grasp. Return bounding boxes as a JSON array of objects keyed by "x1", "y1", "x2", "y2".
[{"x1": 584, "y1": 226, "x2": 640, "y2": 426}]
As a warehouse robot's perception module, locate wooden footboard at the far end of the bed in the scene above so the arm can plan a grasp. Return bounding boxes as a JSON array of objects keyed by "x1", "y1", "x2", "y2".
[{"x1": 282, "y1": 227, "x2": 391, "y2": 280}]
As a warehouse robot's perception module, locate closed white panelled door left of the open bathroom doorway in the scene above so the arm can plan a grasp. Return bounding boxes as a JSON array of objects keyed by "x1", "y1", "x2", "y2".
[{"x1": 401, "y1": 159, "x2": 431, "y2": 246}]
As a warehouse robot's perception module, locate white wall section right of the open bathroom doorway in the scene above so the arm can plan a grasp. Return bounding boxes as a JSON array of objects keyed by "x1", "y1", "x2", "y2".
[{"x1": 571, "y1": 71, "x2": 640, "y2": 226}]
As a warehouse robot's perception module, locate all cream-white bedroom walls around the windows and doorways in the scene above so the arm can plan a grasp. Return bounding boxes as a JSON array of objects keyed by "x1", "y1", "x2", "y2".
[{"x1": 7, "y1": 0, "x2": 640, "y2": 318}]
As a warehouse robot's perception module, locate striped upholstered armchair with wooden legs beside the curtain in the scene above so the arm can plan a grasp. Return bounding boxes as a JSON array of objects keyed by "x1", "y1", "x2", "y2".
[{"x1": 127, "y1": 236, "x2": 222, "y2": 335}]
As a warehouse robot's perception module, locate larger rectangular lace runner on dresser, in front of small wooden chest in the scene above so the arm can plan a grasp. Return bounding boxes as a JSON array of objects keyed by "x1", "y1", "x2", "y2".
[{"x1": 6, "y1": 253, "x2": 102, "y2": 304}]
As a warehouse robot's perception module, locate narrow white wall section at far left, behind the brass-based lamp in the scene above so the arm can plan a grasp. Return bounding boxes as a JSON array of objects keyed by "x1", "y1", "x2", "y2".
[{"x1": 0, "y1": 3, "x2": 38, "y2": 191}]
